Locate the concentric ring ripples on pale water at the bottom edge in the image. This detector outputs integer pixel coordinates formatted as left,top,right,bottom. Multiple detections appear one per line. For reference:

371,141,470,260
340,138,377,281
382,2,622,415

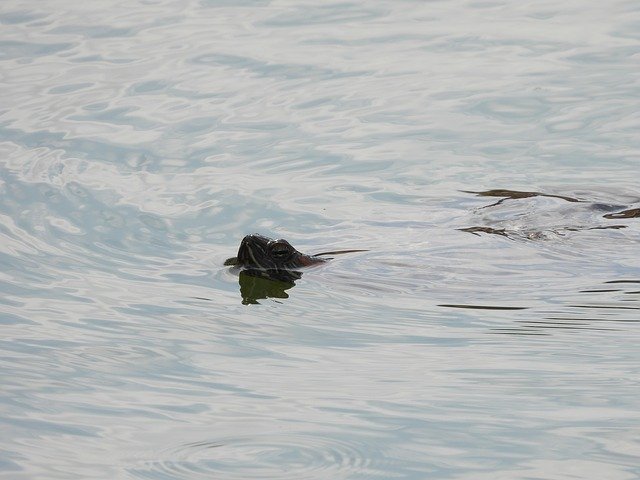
131,433,389,479
